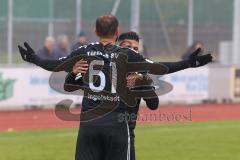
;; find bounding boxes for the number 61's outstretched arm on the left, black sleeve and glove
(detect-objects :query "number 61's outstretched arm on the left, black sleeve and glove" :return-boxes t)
[18,42,82,71]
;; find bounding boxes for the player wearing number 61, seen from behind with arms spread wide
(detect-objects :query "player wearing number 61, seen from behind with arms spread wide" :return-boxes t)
[18,15,212,160]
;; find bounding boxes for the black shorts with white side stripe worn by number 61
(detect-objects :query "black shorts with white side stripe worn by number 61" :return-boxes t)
[75,122,130,160]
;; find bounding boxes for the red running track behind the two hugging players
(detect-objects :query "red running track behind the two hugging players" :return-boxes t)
[0,104,240,131]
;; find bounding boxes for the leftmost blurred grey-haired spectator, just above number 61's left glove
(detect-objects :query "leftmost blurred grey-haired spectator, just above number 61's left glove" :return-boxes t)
[37,37,57,60]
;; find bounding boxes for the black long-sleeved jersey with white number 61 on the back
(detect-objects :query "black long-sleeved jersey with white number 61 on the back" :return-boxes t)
[34,42,188,124]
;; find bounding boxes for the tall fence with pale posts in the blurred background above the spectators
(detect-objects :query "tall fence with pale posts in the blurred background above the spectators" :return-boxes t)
[0,0,233,63]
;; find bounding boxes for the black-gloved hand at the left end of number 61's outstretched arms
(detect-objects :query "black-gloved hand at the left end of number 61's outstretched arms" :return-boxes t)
[18,42,36,63]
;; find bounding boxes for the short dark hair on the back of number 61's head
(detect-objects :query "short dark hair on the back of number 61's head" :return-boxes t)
[96,15,119,37]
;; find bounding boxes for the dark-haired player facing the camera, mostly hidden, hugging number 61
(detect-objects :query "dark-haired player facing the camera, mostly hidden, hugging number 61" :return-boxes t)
[66,32,159,160]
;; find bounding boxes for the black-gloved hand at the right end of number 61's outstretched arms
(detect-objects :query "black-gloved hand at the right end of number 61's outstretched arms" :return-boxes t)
[188,48,212,67]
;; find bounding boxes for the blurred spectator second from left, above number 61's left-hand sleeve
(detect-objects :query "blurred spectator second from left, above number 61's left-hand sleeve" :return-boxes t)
[53,35,69,58]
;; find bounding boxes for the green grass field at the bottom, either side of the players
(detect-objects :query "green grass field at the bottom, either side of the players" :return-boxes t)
[0,121,240,160]
